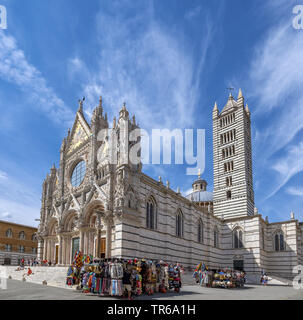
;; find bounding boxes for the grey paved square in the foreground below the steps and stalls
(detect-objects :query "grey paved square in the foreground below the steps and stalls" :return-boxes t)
[0,280,303,301]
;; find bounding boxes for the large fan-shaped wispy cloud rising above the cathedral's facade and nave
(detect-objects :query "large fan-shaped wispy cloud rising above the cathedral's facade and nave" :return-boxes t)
[69,2,213,129]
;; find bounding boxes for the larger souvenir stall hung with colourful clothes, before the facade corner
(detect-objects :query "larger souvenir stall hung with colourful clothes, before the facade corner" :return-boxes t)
[66,252,184,300]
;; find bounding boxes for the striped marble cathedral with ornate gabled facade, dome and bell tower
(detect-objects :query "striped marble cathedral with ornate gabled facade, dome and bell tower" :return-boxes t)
[38,90,303,278]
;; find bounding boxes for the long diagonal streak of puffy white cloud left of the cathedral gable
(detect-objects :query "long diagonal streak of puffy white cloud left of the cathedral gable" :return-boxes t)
[0,30,72,121]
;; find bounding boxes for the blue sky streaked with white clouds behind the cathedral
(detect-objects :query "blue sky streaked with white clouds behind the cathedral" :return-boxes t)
[0,0,303,225]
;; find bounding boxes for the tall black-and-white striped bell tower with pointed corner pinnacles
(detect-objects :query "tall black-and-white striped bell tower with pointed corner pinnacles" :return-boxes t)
[213,89,254,219]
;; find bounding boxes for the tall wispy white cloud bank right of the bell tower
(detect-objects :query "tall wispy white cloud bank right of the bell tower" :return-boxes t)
[246,5,303,199]
